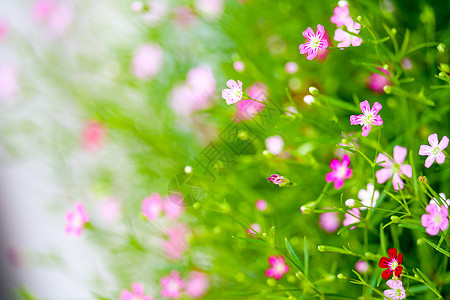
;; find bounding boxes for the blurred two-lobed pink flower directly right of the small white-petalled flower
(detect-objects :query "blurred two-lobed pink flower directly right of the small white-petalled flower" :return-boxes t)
[234,82,267,122]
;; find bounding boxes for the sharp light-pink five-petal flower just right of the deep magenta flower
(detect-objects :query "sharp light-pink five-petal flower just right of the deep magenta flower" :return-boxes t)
[375,146,412,191]
